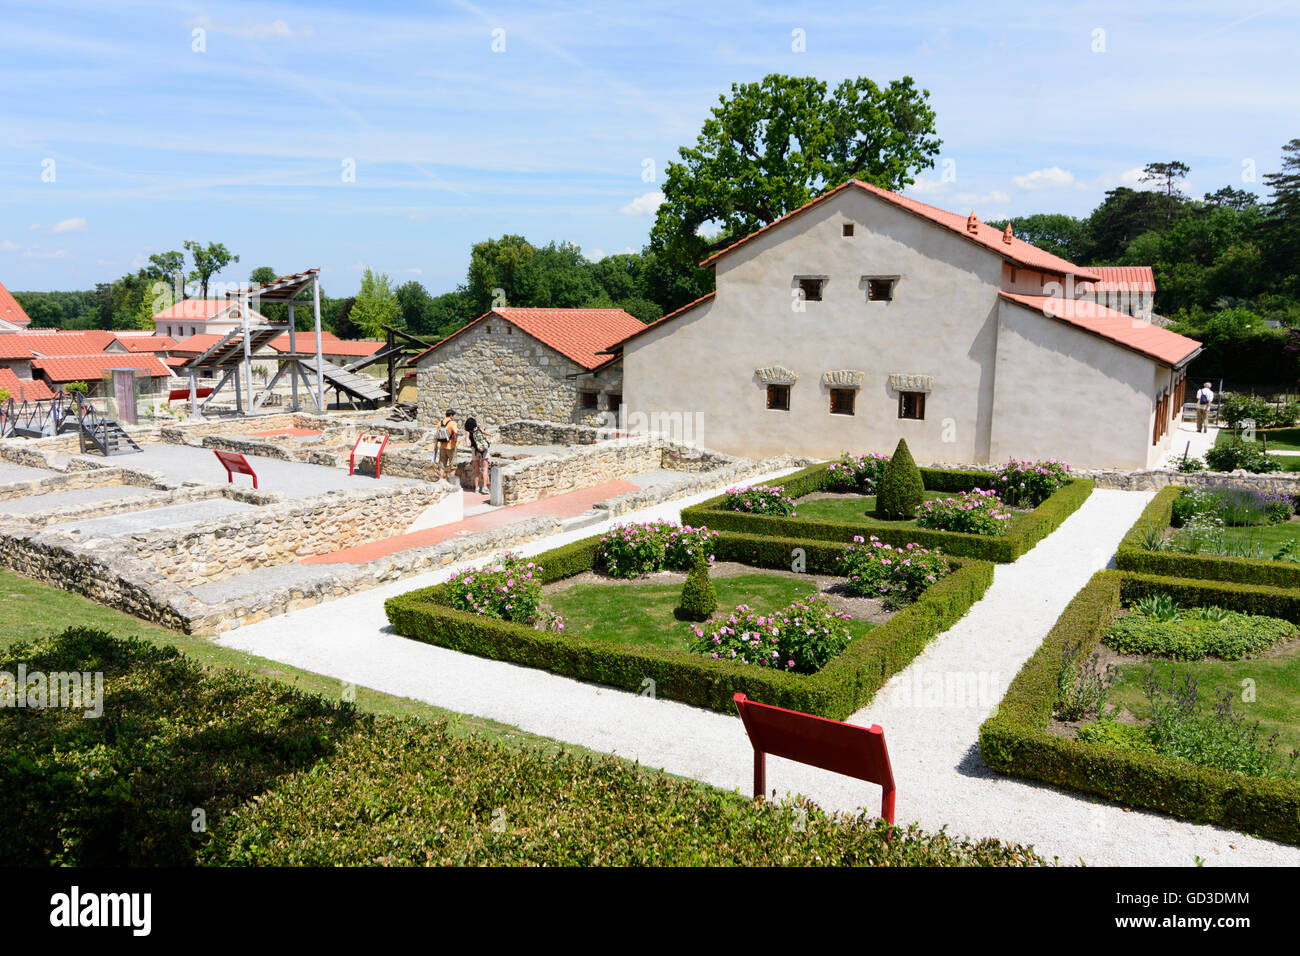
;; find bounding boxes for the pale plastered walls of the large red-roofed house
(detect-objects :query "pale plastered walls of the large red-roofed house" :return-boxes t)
[624,190,1170,467]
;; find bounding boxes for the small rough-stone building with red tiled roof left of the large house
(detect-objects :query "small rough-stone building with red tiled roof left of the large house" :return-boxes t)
[410,308,645,427]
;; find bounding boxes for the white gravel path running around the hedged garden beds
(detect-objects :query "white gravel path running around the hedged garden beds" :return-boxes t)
[220,481,1300,866]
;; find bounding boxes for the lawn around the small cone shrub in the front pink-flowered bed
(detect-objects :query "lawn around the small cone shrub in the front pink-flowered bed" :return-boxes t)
[545,571,874,650]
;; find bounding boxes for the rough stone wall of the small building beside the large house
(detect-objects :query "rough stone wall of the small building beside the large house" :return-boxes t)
[416,315,623,431]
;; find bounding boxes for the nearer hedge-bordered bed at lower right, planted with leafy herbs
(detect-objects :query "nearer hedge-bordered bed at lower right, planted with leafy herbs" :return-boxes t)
[980,571,1300,843]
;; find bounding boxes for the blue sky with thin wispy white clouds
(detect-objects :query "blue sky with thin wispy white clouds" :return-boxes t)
[0,0,1300,295]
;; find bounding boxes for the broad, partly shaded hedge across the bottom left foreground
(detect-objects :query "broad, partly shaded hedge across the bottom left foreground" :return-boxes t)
[0,630,1044,866]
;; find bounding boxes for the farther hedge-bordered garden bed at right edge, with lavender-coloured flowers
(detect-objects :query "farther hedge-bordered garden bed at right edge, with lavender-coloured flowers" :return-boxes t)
[1115,485,1300,589]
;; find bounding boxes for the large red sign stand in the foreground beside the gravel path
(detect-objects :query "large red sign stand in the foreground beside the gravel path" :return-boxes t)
[732,693,894,823]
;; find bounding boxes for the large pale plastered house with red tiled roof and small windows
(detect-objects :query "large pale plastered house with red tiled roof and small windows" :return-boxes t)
[613,181,1200,468]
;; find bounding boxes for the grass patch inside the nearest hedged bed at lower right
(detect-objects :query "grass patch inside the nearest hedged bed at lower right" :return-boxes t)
[1109,650,1300,753]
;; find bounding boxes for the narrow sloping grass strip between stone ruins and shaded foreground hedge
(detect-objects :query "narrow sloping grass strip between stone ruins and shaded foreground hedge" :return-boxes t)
[0,568,575,749]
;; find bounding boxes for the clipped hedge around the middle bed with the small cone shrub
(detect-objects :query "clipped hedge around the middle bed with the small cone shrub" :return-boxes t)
[385,532,993,719]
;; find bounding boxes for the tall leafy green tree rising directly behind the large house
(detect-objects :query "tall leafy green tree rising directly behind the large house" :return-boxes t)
[650,74,941,268]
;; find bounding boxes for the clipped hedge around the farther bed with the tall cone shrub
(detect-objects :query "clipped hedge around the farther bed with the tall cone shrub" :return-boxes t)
[681,464,1093,562]
